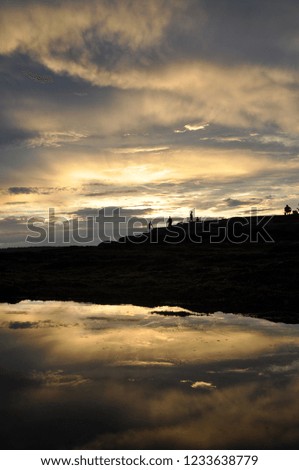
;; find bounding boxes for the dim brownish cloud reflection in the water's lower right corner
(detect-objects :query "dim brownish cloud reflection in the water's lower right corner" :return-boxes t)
[84,380,298,449]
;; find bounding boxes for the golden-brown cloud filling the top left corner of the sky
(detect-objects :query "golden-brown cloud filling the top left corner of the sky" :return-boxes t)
[1,0,179,56]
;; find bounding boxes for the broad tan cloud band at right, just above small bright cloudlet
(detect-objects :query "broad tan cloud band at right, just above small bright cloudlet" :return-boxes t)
[23,61,299,132]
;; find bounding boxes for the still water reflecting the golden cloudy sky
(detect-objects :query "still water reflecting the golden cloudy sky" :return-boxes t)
[0,301,299,449]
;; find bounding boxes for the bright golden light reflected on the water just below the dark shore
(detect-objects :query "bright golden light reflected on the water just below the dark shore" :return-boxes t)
[3,302,299,367]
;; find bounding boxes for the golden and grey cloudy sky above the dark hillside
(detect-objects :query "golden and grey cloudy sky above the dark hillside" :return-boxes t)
[0,0,299,247]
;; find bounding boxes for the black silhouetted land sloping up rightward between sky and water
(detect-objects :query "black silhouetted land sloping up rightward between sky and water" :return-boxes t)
[0,215,299,323]
